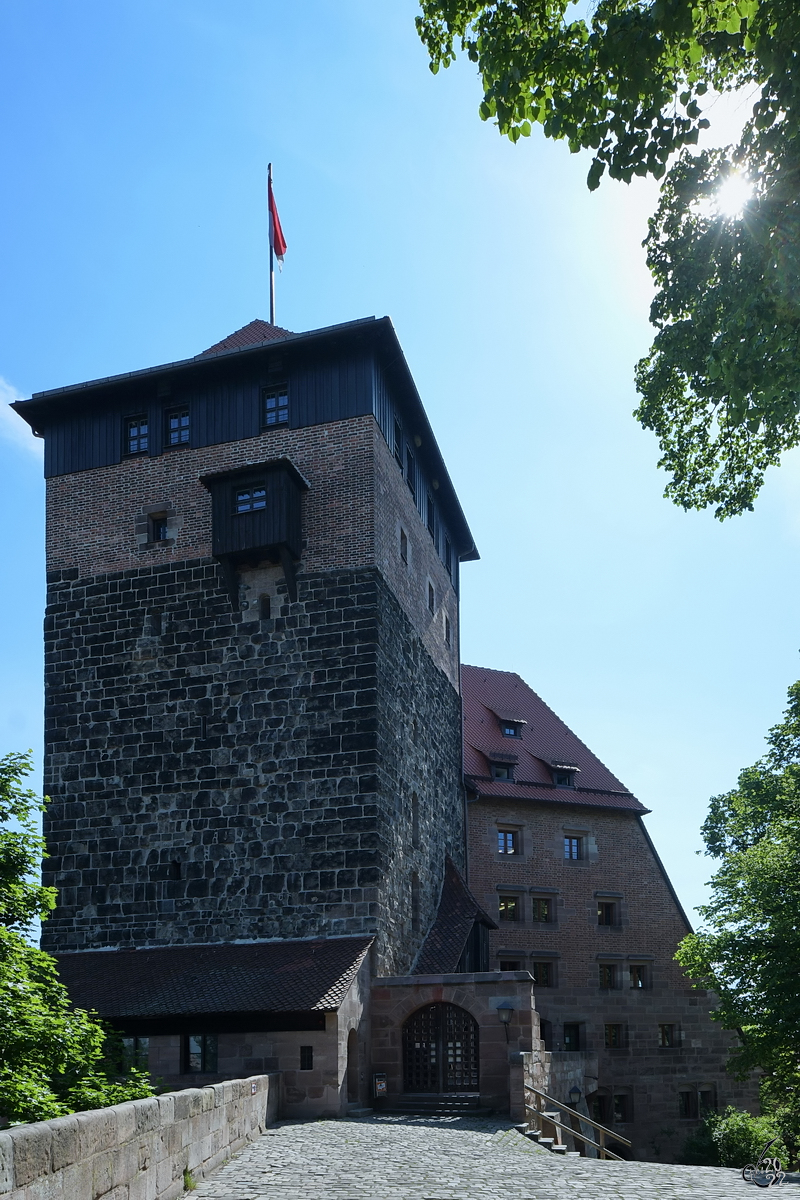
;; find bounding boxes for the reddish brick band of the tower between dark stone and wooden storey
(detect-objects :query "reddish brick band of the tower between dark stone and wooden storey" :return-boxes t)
[47,416,458,688]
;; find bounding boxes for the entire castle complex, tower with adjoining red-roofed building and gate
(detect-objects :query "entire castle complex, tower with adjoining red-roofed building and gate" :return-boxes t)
[13,318,746,1158]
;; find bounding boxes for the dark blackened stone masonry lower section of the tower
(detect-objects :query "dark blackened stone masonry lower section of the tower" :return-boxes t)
[42,558,463,973]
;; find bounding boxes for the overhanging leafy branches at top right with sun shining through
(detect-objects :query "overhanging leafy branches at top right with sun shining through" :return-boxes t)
[417,0,800,517]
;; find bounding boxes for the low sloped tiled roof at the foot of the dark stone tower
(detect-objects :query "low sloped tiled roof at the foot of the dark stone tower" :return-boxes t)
[56,937,372,1018]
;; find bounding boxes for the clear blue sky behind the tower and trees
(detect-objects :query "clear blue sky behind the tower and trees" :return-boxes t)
[0,0,800,908]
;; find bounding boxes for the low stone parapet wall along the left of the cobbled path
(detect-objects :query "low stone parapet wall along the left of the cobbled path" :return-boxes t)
[0,1074,281,1200]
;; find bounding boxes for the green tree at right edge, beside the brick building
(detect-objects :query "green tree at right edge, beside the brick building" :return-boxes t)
[678,683,800,1153]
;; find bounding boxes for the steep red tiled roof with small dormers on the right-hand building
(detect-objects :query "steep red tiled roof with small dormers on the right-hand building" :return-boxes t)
[462,666,649,812]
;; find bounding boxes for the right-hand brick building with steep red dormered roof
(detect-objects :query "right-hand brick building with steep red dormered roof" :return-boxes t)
[462,666,754,1158]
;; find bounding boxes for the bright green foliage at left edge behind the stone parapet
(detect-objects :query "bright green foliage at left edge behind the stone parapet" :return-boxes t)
[0,754,154,1123]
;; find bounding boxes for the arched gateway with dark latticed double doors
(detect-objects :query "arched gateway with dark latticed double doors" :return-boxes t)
[403,1004,479,1092]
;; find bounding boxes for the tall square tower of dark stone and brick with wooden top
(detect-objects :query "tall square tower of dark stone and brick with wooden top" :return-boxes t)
[14,318,477,974]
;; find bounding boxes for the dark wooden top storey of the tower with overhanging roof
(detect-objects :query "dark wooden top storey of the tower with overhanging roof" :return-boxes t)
[12,317,477,560]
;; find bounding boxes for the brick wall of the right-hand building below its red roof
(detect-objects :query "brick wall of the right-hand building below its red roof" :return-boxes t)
[468,800,757,1159]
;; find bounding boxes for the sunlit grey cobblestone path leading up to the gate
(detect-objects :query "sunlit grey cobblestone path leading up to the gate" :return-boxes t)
[193,1116,762,1200]
